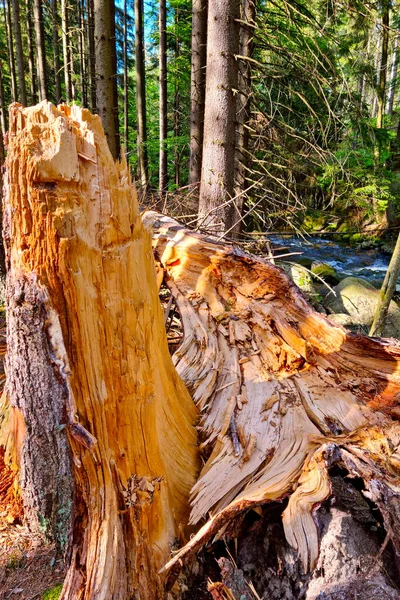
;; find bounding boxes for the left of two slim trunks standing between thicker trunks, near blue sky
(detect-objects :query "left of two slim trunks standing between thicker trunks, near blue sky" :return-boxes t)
[135,0,149,193]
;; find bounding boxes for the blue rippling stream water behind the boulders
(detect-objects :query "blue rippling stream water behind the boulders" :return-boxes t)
[268,235,390,287]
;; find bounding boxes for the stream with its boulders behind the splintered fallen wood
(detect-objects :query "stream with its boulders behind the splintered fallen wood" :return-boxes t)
[268,235,400,339]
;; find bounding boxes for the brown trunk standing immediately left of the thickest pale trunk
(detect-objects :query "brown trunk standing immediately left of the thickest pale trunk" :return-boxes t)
[189,0,208,184]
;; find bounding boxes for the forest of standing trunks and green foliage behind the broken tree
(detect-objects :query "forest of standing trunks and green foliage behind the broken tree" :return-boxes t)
[0,0,400,241]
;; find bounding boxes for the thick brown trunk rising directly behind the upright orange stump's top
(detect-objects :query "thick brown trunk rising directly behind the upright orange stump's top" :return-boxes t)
[94,0,120,158]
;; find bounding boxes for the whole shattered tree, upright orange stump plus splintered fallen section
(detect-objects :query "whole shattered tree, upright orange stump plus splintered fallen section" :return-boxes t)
[5,103,400,600]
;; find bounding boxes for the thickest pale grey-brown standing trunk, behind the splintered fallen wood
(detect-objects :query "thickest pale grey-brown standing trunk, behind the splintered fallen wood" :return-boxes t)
[198,0,240,234]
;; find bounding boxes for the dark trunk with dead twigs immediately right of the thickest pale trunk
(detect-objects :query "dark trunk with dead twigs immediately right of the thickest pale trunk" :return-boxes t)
[231,0,256,233]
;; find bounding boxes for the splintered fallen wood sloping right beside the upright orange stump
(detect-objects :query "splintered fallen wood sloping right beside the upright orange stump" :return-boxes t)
[143,212,400,578]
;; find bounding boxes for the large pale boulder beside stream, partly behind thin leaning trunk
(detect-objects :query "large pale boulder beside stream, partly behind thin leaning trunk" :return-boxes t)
[324,277,400,339]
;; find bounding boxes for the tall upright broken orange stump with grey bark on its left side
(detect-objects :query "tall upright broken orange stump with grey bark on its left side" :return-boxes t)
[5,102,197,600]
